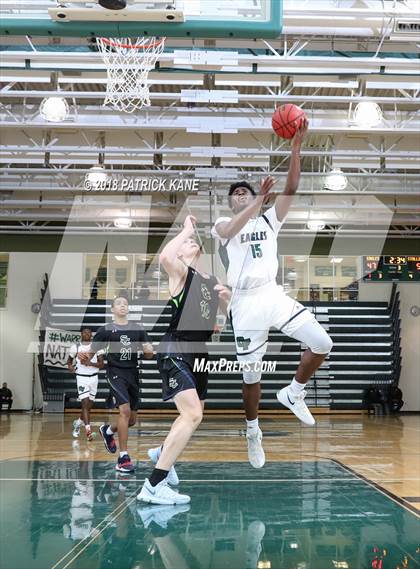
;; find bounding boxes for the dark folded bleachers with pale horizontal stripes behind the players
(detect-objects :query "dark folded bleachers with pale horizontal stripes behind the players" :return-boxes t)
[39,272,401,410]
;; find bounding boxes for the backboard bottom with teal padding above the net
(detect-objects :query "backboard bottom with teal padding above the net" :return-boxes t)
[0,0,282,38]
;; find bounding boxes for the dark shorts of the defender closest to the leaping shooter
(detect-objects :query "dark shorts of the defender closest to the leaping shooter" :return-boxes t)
[158,354,208,401]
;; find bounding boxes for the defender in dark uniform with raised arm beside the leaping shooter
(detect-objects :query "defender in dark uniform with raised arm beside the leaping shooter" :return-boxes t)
[137,215,230,504]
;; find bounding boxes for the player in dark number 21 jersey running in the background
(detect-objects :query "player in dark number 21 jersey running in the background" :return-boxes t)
[82,296,153,472]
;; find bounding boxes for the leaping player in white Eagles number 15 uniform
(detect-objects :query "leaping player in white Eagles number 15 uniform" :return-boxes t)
[212,119,332,468]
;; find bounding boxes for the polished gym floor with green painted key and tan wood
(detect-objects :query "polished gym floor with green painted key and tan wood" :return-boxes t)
[0,413,420,569]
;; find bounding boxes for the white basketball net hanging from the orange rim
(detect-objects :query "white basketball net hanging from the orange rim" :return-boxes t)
[97,37,166,113]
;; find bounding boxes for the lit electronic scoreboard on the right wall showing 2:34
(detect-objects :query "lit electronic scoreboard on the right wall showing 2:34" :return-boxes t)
[363,255,420,282]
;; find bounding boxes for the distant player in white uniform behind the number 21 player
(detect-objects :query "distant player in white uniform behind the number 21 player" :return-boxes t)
[67,327,104,441]
